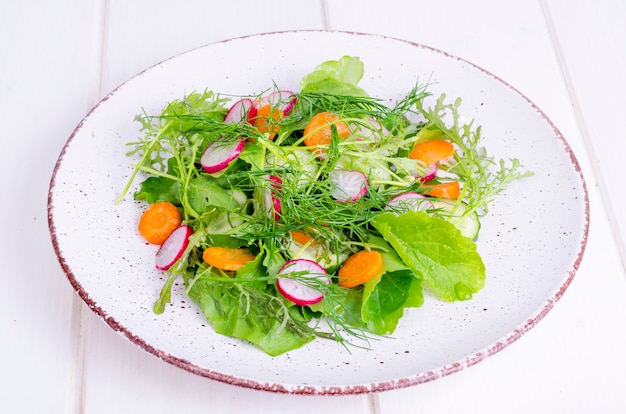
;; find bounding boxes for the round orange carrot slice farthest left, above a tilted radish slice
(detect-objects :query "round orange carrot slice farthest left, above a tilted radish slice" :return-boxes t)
[137,201,182,245]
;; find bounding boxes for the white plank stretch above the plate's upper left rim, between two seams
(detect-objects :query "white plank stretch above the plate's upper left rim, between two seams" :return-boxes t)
[99,0,324,94]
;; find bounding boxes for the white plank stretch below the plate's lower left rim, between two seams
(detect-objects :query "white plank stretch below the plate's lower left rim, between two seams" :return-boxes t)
[85,310,371,414]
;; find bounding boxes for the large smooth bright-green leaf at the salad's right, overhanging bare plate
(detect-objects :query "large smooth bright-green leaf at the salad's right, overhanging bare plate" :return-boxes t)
[371,211,486,302]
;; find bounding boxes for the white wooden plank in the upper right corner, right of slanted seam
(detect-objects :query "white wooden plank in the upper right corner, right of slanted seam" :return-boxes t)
[545,0,626,261]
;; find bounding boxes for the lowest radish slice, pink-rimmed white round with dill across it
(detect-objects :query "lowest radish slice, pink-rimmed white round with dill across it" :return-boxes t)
[276,259,330,306]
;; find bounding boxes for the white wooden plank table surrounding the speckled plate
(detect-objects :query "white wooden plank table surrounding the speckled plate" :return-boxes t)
[0,0,626,414]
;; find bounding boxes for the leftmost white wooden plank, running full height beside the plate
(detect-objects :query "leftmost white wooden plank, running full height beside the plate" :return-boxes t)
[0,0,97,413]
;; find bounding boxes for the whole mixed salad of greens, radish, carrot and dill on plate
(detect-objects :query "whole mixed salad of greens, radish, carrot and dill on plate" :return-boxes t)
[118,56,530,356]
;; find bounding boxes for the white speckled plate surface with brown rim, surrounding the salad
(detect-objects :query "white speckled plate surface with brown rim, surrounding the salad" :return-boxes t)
[49,31,589,394]
